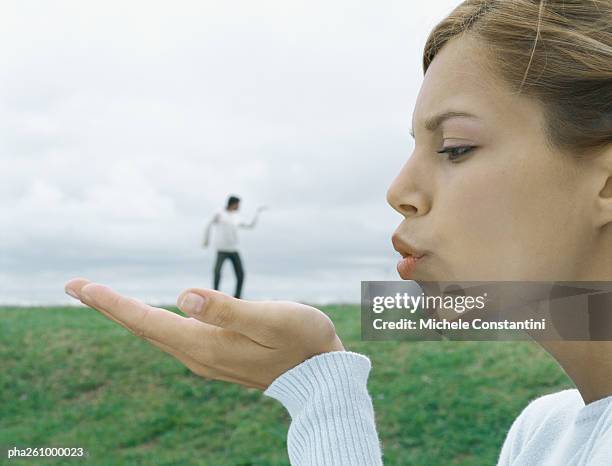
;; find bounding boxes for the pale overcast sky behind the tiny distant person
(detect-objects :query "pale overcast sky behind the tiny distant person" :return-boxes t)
[0,0,459,304]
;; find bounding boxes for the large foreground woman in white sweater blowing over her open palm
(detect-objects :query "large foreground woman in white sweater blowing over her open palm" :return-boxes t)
[66,0,612,465]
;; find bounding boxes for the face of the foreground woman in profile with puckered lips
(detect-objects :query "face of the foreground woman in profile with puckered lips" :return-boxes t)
[388,36,593,281]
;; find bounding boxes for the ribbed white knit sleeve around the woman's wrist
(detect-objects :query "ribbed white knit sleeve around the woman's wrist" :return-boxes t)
[264,351,382,466]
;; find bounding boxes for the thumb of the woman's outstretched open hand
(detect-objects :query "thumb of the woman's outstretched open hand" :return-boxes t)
[177,288,291,344]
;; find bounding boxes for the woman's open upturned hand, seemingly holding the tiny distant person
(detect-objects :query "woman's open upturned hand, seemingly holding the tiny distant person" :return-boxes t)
[65,278,344,390]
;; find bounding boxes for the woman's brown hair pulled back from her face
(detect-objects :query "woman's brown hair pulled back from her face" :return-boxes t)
[423,0,612,156]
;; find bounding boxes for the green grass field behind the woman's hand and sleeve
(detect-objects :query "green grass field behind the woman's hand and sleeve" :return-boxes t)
[0,306,572,466]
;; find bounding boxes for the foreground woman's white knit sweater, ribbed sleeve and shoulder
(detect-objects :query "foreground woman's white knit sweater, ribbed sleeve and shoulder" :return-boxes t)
[264,351,612,466]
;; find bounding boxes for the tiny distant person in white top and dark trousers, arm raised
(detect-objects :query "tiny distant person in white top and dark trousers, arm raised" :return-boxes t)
[202,196,266,298]
